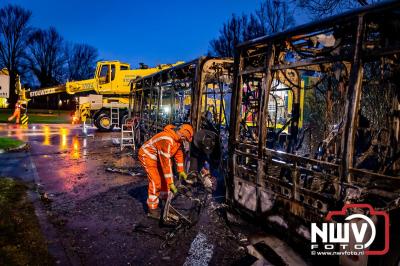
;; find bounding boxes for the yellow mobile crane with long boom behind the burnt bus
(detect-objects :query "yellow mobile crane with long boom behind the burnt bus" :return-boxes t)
[30,61,183,131]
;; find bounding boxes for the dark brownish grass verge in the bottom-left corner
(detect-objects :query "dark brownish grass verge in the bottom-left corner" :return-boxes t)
[0,177,54,265]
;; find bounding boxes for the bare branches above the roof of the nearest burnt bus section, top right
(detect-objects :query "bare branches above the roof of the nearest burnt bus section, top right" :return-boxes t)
[296,0,381,16]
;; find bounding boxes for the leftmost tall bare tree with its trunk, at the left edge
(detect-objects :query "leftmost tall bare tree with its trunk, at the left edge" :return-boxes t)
[0,5,31,105]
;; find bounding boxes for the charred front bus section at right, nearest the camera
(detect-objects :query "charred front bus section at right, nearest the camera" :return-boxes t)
[226,1,400,265]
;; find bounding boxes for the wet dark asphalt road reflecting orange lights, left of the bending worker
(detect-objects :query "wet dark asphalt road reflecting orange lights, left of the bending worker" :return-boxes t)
[0,124,253,265]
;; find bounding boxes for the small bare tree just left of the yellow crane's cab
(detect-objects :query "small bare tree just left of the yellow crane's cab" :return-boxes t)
[65,44,99,80]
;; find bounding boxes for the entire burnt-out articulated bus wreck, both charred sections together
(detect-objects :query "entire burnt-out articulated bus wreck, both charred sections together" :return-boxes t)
[130,2,400,265]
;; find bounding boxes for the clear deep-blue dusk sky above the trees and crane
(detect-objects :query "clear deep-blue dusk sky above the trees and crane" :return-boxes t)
[0,0,310,67]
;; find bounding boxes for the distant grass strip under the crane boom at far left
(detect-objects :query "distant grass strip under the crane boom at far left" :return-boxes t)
[0,109,71,124]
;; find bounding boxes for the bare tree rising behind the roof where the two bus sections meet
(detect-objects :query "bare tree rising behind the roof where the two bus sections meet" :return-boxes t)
[209,0,294,57]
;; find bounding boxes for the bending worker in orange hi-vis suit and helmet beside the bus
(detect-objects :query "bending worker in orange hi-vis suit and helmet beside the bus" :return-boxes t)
[139,124,193,219]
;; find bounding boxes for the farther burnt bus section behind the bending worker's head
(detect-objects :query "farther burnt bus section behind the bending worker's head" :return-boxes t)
[130,57,233,168]
